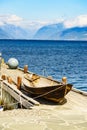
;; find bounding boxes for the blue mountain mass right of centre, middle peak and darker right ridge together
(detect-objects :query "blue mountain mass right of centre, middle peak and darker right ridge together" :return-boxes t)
[34,23,87,40]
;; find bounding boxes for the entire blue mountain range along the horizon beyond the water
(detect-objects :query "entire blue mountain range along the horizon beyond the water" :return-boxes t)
[0,23,87,40]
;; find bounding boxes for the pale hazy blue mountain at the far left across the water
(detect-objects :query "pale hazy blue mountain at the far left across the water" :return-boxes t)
[0,24,31,39]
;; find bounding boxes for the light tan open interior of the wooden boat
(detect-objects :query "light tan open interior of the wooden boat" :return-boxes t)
[24,74,62,87]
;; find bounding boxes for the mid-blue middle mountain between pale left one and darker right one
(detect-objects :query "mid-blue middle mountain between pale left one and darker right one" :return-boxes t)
[33,23,65,40]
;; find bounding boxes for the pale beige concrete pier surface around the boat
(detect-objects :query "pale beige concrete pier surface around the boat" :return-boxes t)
[0,64,87,130]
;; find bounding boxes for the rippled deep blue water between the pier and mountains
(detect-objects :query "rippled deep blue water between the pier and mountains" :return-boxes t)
[0,40,87,91]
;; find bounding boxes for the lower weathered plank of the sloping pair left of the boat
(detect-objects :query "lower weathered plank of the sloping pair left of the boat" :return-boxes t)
[3,84,33,108]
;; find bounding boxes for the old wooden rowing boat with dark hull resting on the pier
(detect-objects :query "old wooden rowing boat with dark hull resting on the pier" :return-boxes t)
[23,73,72,103]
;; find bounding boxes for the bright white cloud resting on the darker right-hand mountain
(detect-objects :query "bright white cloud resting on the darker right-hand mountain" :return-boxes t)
[64,15,87,28]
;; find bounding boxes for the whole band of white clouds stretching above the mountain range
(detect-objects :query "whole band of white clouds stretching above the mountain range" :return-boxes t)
[0,14,87,31]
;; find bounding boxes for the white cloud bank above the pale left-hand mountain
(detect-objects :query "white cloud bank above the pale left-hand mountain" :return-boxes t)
[0,14,48,30]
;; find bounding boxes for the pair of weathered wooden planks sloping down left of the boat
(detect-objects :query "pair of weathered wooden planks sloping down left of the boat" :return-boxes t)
[3,81,39,108]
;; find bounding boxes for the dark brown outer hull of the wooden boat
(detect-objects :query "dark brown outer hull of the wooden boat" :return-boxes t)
[24,84,72,102]
